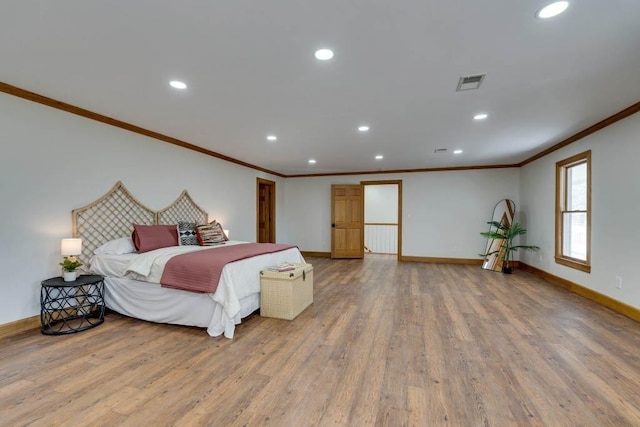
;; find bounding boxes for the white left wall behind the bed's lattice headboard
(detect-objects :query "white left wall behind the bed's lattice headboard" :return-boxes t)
[0,94,283,324]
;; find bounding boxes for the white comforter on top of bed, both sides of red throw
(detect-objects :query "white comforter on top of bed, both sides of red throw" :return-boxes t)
[92,241,304,319]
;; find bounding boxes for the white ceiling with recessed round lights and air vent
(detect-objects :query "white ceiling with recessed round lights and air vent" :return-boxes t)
[0,0,640,175]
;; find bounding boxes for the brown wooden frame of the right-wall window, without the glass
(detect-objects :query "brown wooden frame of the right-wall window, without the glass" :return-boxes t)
[555,150,591,273]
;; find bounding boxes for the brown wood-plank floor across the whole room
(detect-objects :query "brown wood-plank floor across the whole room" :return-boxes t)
[0,256,640,426]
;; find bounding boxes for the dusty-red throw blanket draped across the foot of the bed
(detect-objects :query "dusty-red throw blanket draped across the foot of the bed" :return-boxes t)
[160,243,295,293]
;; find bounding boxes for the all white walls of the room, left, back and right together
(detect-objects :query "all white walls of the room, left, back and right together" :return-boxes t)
[5,87,640,324]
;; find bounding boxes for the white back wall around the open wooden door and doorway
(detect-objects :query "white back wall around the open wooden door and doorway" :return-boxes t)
[283,168,519,258]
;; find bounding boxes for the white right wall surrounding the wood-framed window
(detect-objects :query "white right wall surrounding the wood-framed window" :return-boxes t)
[520,110,640,307]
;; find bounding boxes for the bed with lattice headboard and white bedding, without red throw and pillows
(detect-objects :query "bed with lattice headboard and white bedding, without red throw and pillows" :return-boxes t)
[72,182,304,338]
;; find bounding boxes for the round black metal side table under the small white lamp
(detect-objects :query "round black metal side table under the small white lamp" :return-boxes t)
[40,275,104,335]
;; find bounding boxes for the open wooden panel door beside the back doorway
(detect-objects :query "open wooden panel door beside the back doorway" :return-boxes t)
[331,185,364,258]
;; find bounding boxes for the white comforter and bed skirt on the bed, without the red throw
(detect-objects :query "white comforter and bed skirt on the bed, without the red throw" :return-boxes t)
[90,241,304,338]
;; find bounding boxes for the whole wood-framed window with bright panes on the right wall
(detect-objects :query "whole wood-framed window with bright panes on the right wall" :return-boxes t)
[556,151,591,273]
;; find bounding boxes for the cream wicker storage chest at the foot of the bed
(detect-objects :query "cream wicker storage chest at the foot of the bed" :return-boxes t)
[260,264,313,320]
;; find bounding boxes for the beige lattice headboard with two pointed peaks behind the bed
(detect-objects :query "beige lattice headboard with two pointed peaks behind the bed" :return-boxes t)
[71,181,209,263]
